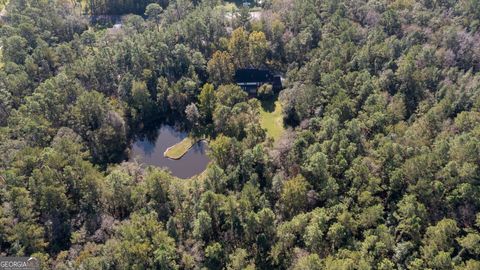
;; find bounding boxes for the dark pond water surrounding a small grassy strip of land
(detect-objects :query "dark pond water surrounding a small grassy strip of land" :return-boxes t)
[131,125,210,178]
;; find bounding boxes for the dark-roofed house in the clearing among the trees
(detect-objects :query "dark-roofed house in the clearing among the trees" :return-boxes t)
[235,68,282,95]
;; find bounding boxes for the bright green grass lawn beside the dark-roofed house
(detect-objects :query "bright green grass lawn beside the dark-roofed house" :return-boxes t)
[260,100,285,141]
